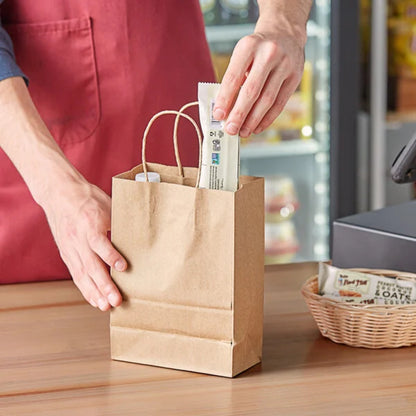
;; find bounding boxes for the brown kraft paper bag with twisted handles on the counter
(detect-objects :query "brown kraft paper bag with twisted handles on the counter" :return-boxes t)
[110,107,264,377]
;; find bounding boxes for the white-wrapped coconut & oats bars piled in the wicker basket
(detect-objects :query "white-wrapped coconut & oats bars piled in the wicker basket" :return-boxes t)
[318,263,416,305]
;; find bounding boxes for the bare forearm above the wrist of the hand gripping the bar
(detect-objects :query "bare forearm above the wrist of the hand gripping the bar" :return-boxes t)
[256,0,313,45]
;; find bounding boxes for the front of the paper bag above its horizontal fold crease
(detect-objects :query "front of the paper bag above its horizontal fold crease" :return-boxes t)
[112,179,234,310]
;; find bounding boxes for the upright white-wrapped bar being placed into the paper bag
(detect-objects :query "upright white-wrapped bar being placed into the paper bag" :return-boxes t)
[198,82,240,192]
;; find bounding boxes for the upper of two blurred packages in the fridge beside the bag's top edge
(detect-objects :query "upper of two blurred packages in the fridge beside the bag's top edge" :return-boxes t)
[264,176,299,222]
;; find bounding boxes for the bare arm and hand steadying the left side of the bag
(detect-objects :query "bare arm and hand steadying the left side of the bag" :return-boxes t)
[0,77,127,310]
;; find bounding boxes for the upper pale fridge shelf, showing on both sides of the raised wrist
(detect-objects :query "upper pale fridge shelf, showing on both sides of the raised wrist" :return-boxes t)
[205,20,323,43]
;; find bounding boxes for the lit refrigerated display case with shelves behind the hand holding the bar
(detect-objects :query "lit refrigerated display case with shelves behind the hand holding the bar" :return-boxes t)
[201,0,331,263]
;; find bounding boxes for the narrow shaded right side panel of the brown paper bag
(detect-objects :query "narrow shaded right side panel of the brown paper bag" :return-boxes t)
[233,178,264,376]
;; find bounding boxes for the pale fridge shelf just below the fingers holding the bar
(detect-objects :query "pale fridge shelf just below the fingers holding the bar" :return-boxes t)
[240,139,320,159]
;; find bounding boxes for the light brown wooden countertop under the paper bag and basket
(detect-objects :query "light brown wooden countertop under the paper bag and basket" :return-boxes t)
[0,263,416,416]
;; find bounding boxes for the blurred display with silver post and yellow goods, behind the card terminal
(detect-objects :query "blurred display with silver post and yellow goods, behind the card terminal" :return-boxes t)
[358,0,416,211]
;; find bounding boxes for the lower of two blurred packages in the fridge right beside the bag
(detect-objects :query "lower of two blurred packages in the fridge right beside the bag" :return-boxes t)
[264,220,299,264]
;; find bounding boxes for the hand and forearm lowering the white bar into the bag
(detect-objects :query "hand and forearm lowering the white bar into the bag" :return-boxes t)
[214,0,312,137]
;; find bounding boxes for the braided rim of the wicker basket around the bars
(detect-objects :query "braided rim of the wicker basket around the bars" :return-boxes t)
[301,268,416,312]
